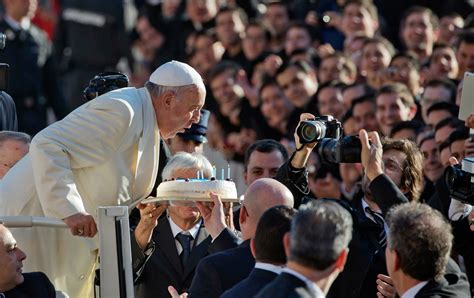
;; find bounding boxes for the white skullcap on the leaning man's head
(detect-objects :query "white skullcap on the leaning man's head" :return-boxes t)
[150,60,204,87]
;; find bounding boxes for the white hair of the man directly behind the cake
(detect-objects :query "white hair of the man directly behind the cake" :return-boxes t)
[161,152,212,180]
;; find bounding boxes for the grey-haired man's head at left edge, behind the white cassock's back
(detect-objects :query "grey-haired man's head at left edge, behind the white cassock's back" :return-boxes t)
[0,130,31,179]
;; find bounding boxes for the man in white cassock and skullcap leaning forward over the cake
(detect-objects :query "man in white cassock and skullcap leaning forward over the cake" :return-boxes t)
[0,61,206,297]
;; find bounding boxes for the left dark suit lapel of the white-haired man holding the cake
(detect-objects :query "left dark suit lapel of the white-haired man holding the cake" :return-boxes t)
[153,216,183,275]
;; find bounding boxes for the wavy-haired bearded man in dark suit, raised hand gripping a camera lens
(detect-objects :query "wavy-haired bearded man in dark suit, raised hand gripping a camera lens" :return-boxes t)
[327,130,423,297]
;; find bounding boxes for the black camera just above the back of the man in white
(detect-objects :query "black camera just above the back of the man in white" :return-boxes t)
[83,71,128,101]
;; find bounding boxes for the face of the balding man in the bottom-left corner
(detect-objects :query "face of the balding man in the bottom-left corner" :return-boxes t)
[0,226,26,292]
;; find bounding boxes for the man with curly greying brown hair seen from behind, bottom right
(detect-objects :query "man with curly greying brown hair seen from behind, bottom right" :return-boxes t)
[385,202,470,297]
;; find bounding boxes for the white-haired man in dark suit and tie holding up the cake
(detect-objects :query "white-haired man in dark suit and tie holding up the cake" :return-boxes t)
[131,152,234,297]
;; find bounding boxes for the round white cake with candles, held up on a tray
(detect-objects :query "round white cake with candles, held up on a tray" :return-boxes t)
[140,178,238,203]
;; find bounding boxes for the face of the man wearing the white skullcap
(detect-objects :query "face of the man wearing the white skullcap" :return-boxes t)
[159,85,206,139]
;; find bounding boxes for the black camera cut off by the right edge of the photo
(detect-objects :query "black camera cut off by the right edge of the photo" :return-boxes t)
[444,157,474,205]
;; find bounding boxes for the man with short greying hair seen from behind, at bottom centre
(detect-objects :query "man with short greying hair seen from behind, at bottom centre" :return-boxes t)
[256,199,352,298]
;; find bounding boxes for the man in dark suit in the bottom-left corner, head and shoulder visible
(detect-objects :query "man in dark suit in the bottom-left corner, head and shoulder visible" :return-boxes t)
[0,224,56,298]
